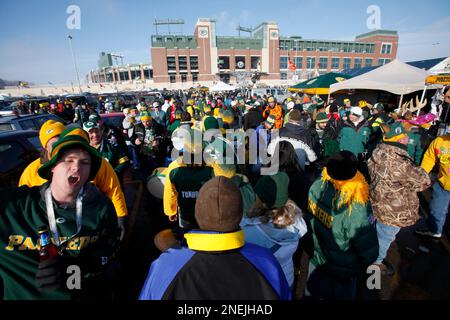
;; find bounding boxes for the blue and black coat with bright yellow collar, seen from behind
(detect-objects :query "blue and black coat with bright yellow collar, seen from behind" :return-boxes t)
[139,230,291,300]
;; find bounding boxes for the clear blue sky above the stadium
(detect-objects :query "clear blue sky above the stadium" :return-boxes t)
[0,0,450,84]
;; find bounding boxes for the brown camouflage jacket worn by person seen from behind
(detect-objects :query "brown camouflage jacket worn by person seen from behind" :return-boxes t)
[368,143,431,227]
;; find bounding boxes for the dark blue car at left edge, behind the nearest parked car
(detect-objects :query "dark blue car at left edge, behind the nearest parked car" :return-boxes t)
[0,113,66,131]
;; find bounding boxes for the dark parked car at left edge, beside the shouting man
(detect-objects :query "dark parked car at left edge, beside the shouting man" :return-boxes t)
[0,130,42,187]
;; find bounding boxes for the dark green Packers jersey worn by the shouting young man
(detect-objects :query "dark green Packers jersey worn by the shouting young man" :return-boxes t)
[0,183,120,300]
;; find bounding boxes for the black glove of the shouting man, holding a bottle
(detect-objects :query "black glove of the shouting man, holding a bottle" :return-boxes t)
[36,256,63,291]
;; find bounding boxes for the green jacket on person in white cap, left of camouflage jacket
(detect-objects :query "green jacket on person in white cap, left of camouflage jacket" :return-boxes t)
[338,121,370,157]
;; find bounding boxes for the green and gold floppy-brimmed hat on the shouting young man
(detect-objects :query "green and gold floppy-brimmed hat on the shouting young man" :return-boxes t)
[38,127,102,181]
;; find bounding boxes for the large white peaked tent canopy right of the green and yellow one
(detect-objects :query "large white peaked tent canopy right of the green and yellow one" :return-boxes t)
[330,60,429,95]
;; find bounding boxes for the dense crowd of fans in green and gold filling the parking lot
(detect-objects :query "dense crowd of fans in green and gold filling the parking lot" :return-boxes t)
[0,88,450,299]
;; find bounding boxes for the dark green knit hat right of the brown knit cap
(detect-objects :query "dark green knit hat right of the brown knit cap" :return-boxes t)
[255,172,289,209]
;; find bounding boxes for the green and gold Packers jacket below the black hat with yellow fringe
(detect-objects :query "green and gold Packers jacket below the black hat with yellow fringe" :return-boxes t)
[306,169,378,279]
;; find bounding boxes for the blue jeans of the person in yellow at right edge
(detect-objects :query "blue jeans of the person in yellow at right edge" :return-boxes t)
[427,182,450,234]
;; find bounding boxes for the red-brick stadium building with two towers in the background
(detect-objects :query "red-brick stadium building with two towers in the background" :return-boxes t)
[151,18,398,84]
